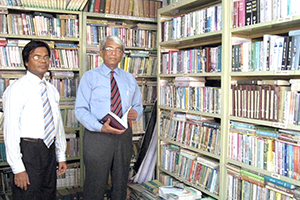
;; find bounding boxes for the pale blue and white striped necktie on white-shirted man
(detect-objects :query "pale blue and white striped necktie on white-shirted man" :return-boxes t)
[41,81,55,148]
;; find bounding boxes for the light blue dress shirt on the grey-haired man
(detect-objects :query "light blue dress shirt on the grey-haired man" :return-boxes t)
[75,64,143,132]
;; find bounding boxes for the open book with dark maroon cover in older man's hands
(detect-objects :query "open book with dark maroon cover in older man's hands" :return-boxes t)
[99,106,131,130]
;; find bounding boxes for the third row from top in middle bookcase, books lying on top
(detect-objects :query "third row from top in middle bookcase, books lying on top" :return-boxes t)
[160,77,221,114]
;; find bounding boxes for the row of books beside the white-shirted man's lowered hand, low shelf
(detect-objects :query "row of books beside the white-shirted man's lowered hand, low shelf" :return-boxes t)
[57,163,80,187]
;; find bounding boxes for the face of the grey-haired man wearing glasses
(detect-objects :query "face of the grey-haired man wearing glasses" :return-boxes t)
[100,40,124,70]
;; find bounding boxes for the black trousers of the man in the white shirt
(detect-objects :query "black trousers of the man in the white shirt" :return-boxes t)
[12,139,56,200]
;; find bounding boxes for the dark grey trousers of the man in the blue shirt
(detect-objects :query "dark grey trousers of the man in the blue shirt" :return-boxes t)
[83,128,132,200]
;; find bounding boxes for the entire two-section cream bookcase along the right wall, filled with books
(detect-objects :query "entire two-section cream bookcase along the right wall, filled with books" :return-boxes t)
[157,0,300,200]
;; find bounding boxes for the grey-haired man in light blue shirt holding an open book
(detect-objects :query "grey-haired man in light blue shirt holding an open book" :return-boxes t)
[75,36,143,200]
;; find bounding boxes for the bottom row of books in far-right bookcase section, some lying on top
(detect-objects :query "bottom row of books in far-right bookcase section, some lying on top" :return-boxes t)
[227,164,300,200]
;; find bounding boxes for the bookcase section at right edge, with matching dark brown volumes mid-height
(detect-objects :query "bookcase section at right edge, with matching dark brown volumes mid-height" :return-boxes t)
[226,1,300,199]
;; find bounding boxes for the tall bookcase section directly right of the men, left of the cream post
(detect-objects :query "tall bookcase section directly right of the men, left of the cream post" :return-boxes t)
[157,0,228,199]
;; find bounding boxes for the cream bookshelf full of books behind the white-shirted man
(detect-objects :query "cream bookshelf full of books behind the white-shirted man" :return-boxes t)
[0,5,83,192]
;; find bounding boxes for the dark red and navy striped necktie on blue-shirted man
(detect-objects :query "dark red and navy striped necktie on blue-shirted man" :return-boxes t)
[110,71,123,117]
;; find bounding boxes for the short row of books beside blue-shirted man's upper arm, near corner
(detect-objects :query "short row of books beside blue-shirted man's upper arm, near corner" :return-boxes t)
[137,80,157,104]
